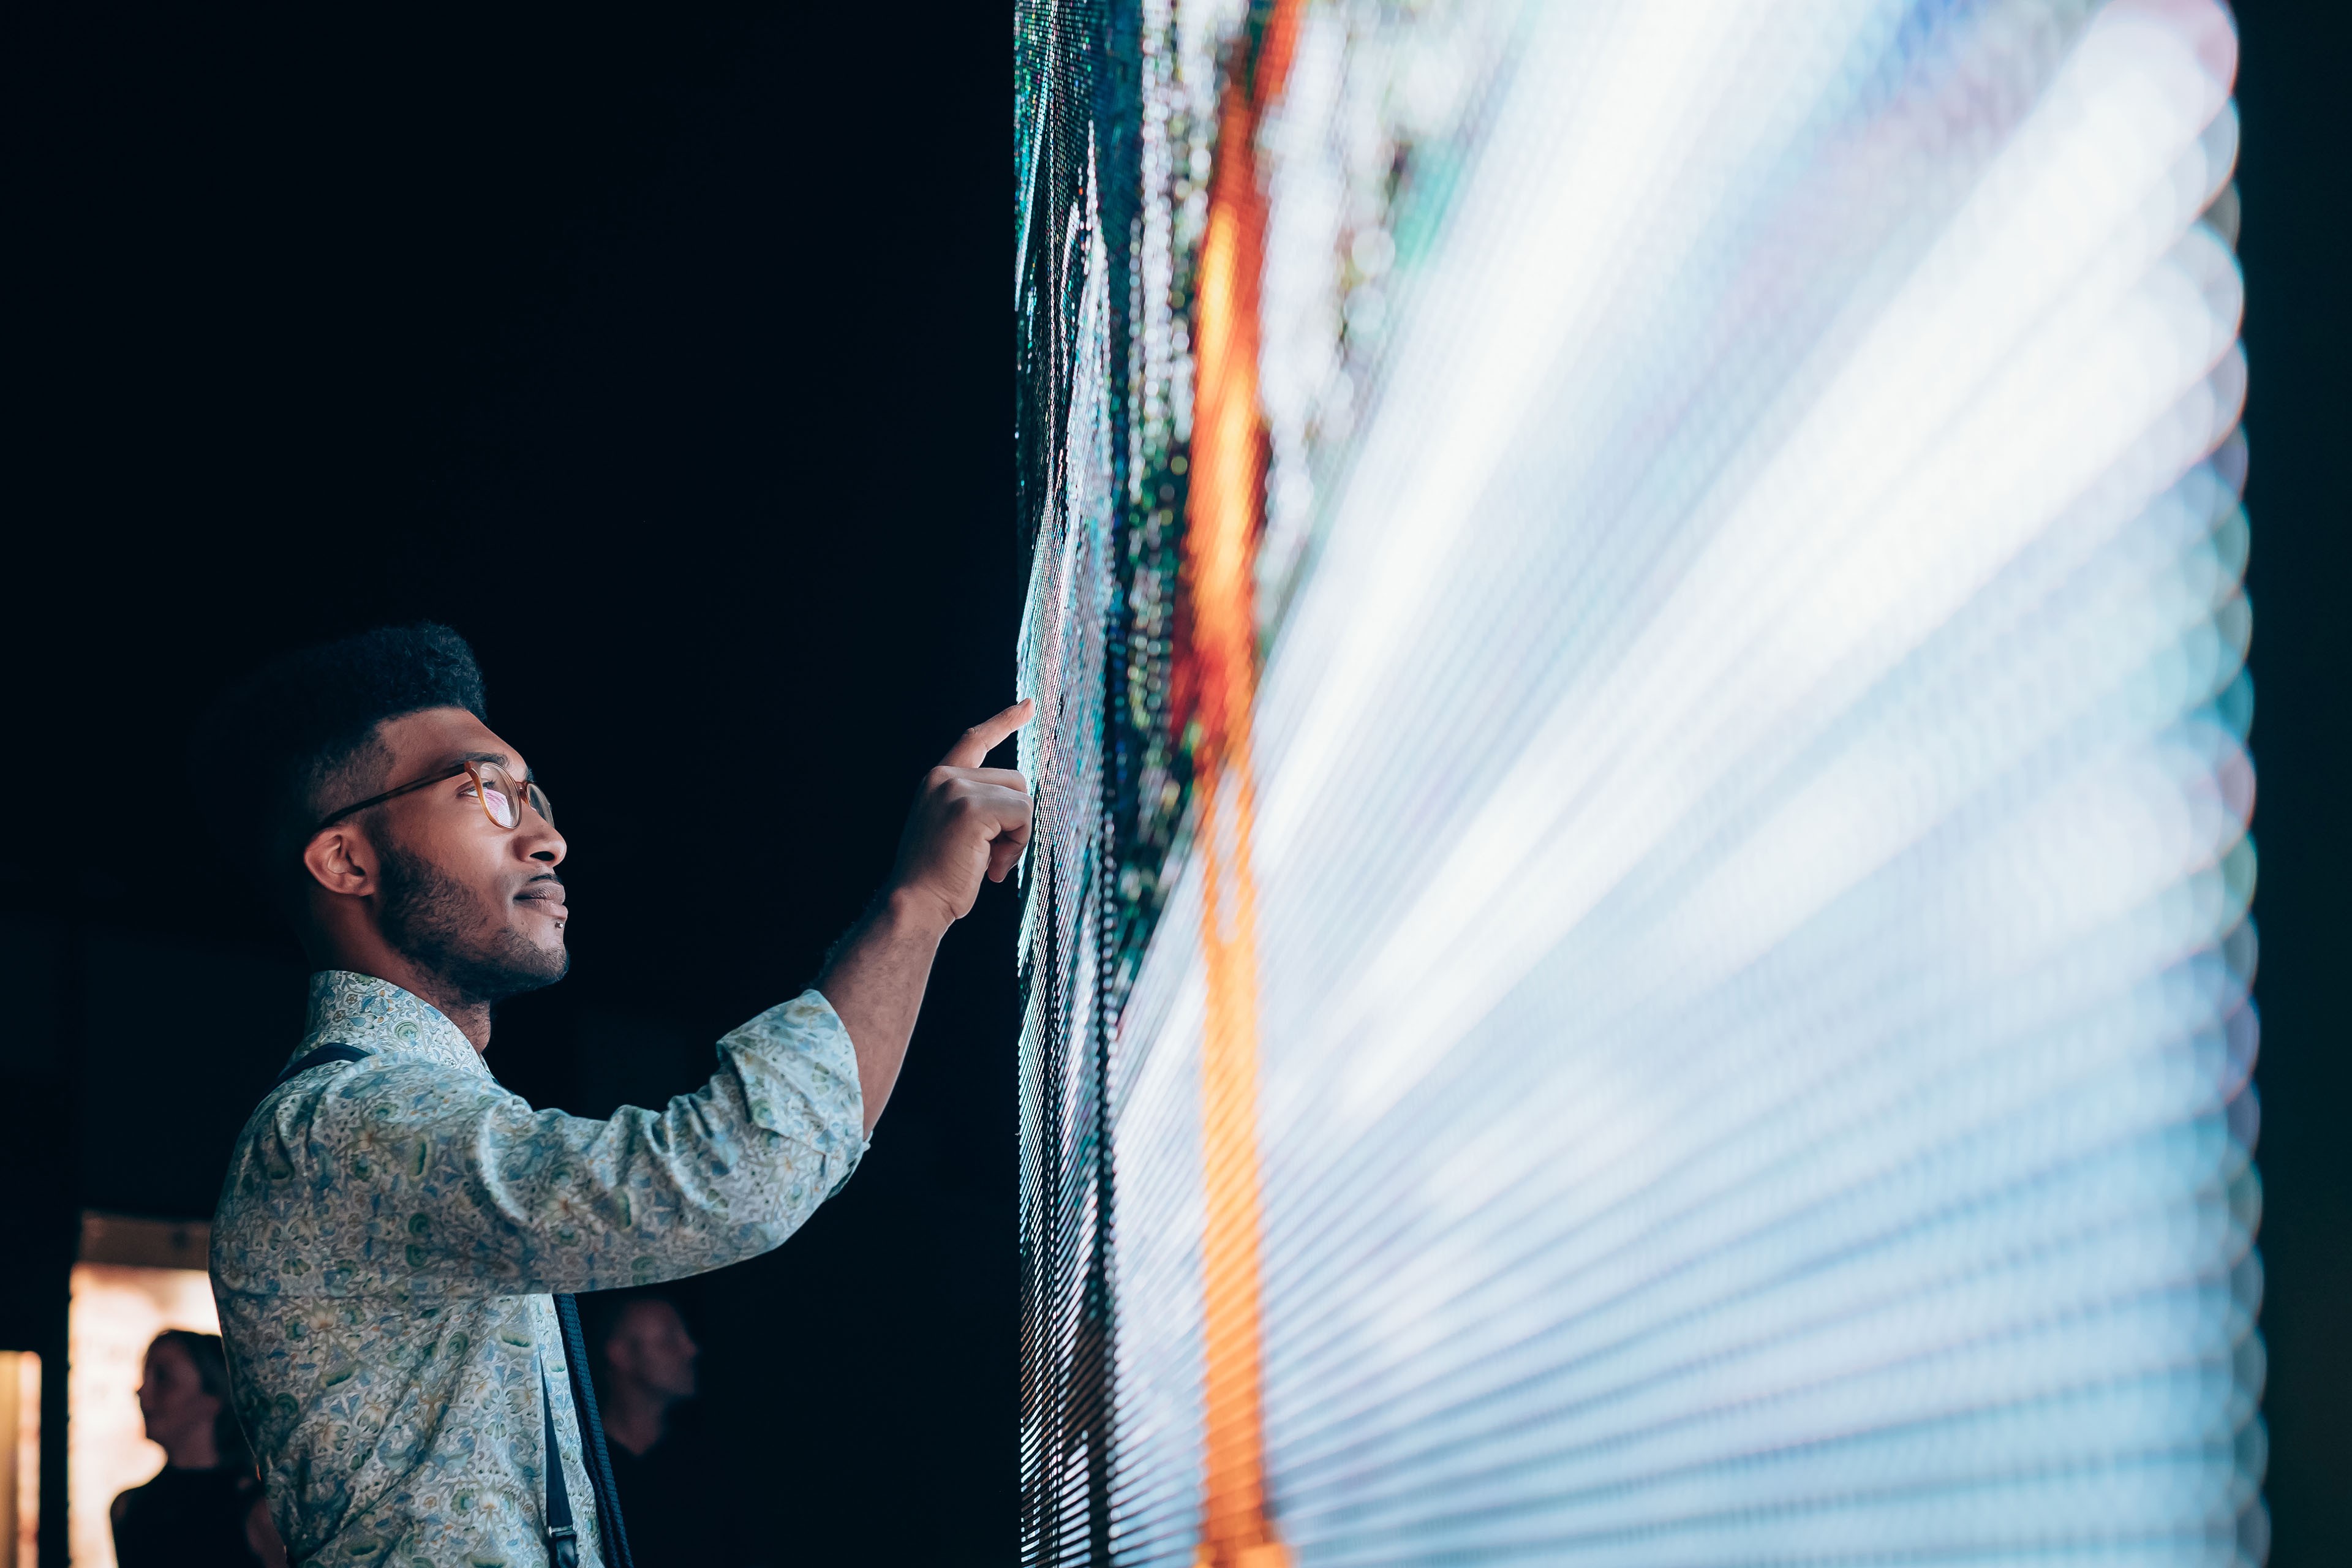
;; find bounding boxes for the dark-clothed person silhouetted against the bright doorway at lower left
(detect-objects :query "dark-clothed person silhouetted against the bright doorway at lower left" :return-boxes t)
[113,1329,287,1568]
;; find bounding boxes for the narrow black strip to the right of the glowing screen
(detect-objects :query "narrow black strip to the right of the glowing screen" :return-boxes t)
[2239,0,2352,1568]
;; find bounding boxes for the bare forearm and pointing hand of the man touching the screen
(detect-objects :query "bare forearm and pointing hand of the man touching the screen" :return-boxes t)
[816,698,1035,1133]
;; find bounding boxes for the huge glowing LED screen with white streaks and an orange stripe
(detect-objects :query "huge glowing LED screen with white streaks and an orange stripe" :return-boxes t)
[1014,0,2267,1568]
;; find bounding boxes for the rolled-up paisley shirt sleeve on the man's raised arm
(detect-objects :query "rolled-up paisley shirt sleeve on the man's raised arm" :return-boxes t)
[233,990,865,1295]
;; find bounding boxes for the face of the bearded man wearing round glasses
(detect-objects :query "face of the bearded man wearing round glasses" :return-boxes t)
[341,707,571,1001]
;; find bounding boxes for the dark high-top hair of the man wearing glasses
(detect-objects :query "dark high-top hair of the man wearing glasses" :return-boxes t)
[190,620,489,905]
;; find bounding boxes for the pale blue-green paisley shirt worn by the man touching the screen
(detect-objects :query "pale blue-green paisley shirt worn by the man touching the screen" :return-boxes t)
[212,971,865,1568]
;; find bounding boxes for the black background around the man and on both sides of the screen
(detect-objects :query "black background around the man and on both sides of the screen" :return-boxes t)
[0,5,2352,1566]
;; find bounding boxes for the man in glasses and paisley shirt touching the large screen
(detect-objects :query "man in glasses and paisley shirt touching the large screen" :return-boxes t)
[198,625,1030,1568]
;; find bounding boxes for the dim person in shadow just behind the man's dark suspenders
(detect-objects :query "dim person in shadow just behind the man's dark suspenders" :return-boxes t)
[590,1295,776,1568]
